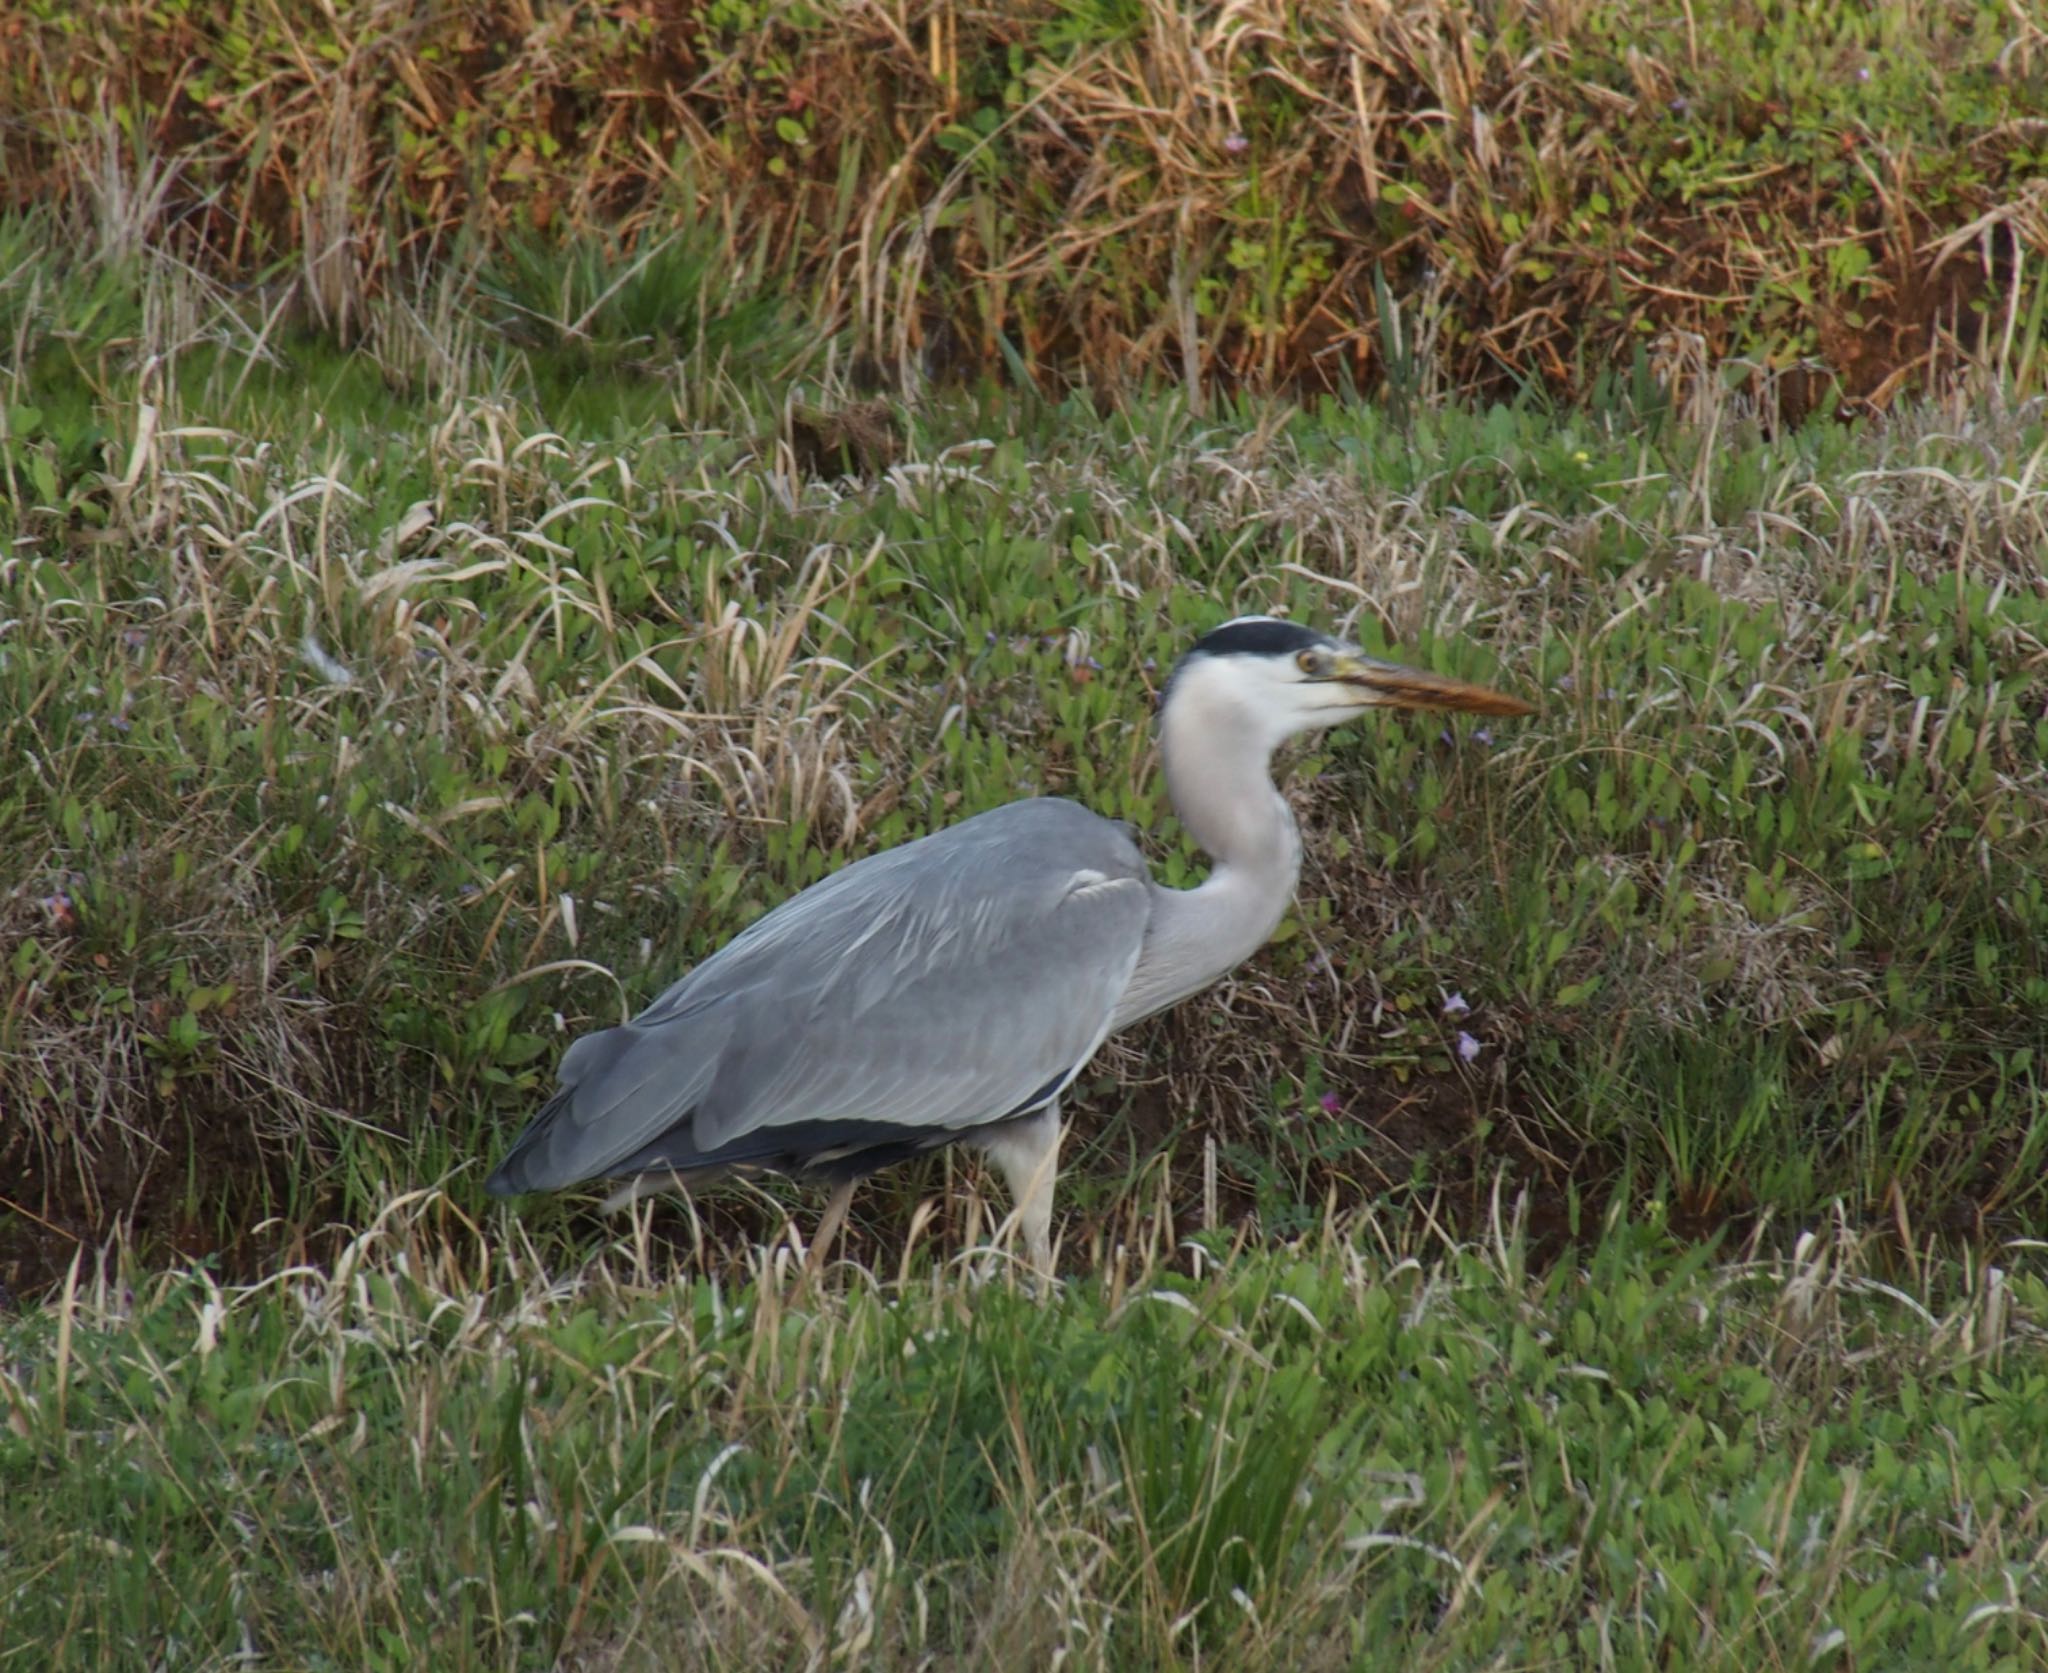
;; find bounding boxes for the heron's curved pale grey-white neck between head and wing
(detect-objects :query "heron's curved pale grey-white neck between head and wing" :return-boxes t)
[1114,683,1300,1028]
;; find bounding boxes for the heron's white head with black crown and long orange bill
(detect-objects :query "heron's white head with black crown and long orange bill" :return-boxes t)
[1159,616,1534,743]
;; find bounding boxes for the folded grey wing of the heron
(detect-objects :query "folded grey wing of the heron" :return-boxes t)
[489,801,1151,1194]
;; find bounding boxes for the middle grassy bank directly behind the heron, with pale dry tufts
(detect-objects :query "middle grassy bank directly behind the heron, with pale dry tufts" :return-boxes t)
[0,205,2048,1288]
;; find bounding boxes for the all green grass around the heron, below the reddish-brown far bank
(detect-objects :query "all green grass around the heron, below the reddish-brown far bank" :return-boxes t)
[0,88,2048,1669]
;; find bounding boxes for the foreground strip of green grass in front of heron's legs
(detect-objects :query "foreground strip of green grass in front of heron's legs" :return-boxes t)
[0,1194,2048,1669]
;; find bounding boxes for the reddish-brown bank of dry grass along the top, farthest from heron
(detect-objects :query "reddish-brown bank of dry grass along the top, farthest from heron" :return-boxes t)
[0,0,2048,401]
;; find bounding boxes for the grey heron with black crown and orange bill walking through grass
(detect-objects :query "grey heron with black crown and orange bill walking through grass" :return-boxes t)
[487,616,1532,1276]
